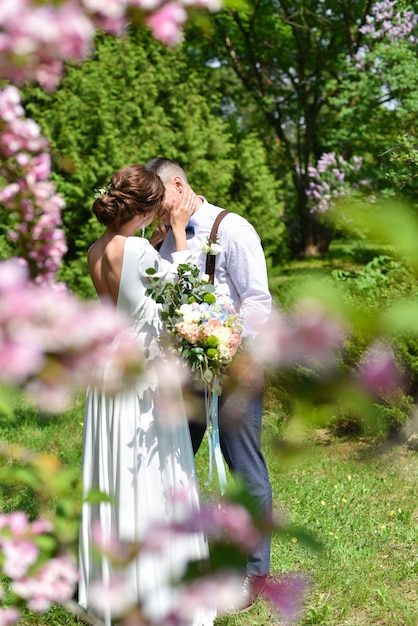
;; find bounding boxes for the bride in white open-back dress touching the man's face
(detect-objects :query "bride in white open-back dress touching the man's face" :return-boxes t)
[79,165,214,626]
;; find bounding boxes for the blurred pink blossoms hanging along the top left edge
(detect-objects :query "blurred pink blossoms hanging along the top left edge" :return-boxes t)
[0,0,220,90]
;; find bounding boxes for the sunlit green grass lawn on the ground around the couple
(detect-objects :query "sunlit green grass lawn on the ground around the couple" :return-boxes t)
[0,396,418,626]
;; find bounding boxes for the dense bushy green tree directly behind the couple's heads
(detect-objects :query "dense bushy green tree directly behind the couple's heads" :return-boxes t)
[25,27,286,295]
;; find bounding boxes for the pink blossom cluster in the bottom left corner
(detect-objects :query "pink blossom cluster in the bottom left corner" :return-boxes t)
[0,511,78,624]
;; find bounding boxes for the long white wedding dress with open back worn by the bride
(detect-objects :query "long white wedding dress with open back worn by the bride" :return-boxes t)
[79,237,215,626]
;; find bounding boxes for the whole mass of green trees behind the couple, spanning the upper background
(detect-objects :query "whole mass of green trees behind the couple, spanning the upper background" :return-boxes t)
[13,0,418,276]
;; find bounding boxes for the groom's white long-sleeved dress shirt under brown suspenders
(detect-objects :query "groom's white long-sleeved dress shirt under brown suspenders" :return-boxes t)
[160,198,271,337]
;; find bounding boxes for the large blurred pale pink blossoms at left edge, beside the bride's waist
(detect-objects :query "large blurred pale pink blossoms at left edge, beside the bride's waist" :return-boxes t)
[0,259,142,410]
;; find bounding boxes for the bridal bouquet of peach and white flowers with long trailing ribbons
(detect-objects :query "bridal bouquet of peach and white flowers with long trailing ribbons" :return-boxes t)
[147,263,242,492]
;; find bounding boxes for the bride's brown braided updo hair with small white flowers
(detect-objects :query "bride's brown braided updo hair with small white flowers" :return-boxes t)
[92,164,165,228]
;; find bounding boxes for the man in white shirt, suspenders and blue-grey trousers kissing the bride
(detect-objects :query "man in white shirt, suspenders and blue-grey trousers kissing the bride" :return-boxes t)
[146,157,272,609]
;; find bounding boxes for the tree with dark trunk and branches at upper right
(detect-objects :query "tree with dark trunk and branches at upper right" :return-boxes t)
[188,0,418,252]
